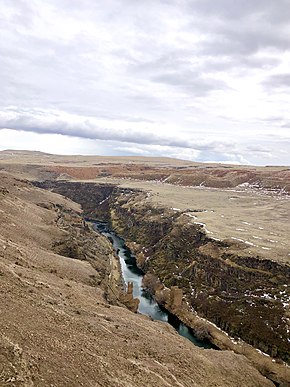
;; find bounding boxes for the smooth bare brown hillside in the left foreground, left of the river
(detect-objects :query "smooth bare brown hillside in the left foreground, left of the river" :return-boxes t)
[0,172,273,387]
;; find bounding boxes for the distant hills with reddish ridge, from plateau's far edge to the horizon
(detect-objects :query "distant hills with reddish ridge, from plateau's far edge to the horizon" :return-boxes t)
[0,150,290,194]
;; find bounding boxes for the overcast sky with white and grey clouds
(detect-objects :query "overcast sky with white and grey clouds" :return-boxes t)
[0,0,290,165]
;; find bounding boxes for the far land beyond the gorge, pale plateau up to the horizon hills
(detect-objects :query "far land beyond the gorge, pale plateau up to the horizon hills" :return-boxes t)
[0,151,290,264]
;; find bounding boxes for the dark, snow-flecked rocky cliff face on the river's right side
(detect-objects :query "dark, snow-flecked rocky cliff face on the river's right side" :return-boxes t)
[111,193,290,362]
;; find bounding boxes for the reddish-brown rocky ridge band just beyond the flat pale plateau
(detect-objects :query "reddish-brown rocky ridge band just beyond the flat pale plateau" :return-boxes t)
[46,164,290,193]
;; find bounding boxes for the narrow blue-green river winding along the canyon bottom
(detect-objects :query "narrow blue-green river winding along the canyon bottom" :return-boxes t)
[93,221,214,348]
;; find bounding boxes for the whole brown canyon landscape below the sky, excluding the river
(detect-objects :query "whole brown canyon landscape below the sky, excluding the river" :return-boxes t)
[0,151,290,386]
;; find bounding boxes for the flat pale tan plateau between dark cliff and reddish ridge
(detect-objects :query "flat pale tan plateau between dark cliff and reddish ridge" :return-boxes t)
[98,178,290,264]
